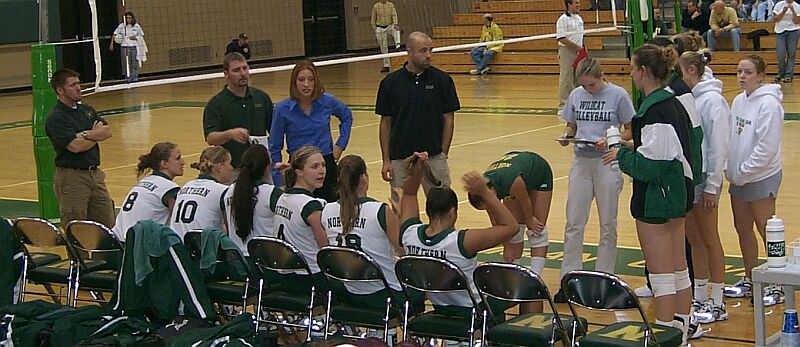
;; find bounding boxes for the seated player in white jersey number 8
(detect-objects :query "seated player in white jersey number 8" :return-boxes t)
[113,142,184,241]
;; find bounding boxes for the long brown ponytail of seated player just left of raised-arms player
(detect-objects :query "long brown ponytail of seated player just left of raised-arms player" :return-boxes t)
[338,155,367,236]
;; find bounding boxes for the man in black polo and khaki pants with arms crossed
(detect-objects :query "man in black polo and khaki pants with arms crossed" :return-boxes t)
[45,69,114,228]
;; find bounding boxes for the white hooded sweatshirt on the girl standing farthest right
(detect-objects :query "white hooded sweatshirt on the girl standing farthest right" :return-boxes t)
[725,84,783,186]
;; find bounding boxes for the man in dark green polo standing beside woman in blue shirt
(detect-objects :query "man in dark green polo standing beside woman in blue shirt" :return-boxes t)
[203,52,272,179]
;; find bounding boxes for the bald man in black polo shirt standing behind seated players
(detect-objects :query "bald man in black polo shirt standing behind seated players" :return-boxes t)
[375,32,461,201]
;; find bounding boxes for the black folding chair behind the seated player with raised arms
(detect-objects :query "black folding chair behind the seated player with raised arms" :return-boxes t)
[395,255,482,346]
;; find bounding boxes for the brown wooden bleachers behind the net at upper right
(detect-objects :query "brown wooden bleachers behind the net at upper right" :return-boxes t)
[392,0,777,74]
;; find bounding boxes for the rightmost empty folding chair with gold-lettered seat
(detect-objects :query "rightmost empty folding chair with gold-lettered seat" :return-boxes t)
[561,270,683,347]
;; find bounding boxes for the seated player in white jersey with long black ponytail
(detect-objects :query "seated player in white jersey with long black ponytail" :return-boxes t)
[223,145,281,256]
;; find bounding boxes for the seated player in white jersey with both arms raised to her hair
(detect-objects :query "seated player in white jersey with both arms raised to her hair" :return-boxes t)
[400,152,517,317]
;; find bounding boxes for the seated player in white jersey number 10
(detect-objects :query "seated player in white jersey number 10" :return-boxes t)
[170,146,233,238]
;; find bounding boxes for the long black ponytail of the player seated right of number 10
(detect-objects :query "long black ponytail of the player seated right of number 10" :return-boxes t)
[231,145,270,240]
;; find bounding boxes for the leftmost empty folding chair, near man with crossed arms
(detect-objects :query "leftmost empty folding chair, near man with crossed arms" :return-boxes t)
[14,217,75,305]
